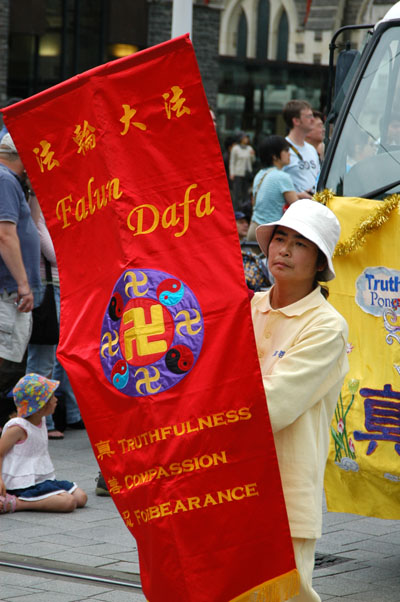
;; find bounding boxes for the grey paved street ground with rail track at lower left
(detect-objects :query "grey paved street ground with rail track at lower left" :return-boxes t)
[0,431,400,602]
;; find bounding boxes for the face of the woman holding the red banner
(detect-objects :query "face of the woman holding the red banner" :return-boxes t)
[268,226,323,285]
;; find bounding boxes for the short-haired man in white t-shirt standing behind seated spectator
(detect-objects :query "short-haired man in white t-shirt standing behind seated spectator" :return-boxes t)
[283,100,320,198]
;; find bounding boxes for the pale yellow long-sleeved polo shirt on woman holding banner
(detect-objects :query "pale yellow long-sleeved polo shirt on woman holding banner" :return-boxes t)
[251,286,348,539]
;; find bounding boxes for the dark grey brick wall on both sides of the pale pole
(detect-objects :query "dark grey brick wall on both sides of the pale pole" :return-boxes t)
[147,0,221,108]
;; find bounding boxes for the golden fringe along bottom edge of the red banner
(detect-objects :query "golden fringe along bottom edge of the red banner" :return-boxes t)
[231,569,300,602]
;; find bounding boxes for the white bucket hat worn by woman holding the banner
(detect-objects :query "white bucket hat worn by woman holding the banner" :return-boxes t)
[256,199,340,282]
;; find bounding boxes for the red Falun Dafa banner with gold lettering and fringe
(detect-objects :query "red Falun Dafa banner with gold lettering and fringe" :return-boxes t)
[5,36,298,602]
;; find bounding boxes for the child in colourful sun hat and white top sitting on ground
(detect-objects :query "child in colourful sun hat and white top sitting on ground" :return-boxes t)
[0,373,87,514]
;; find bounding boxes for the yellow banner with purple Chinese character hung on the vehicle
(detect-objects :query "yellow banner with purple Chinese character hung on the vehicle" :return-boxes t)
[325,197,400,519]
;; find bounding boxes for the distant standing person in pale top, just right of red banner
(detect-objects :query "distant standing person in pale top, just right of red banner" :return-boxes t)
[229,132,255,211]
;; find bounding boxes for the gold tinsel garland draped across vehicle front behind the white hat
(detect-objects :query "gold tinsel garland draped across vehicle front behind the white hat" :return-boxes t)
[314,189,400,257]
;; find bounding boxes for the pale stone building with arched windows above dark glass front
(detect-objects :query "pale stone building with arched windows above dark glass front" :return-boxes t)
[217,0,392,135]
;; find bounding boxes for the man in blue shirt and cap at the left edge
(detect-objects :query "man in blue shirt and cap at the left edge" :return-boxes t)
[0,134,40,363]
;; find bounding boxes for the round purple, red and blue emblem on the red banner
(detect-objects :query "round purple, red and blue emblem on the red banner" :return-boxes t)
[100,269,204,397]
